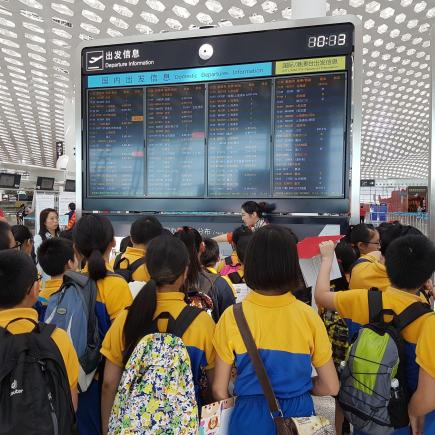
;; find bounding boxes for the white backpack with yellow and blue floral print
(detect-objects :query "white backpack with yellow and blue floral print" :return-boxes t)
[108,306,202,435]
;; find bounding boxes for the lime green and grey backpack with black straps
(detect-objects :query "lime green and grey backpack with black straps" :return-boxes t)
[338,288,431,435]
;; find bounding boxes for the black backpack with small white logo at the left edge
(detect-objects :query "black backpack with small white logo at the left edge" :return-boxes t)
[0,319,76,435]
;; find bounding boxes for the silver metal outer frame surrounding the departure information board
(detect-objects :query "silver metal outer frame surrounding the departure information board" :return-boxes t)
[74,16,362,220]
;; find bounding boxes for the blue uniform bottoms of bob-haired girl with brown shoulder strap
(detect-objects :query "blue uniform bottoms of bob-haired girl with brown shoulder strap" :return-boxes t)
[228,393,314,435]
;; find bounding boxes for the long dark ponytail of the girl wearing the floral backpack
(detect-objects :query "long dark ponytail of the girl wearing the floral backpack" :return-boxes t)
[123,279,157,365]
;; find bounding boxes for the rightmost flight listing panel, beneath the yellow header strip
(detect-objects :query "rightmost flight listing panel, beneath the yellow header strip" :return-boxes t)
[273,73,346,197]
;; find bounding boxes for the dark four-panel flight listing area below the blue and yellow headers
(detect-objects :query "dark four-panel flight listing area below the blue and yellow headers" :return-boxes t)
[88,73,346,198]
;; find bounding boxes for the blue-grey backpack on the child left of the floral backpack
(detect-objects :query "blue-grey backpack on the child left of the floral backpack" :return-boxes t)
[45,271,101,392]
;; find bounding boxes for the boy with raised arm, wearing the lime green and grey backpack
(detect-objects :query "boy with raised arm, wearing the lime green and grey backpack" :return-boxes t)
[315,235,435,434]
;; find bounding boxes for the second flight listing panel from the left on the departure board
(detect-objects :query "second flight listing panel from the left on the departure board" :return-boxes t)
[146,84,205,197]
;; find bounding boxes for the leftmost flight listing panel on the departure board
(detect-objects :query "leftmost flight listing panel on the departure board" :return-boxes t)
[87,88,145,197]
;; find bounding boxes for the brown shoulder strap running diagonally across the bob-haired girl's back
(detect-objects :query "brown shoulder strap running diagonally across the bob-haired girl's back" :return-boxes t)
[233,303,289,433]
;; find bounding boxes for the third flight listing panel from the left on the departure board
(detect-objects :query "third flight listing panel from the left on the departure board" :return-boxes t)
[208,80,271,197]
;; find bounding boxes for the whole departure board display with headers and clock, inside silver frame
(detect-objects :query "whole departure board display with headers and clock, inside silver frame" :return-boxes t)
[82,23,353,211]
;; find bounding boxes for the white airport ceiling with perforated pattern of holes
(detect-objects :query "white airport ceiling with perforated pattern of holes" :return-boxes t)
[0,0,435,178]
